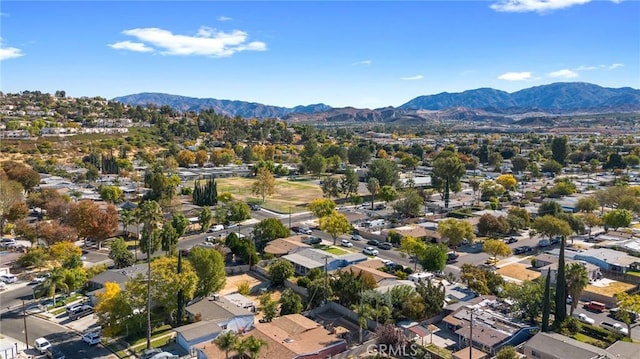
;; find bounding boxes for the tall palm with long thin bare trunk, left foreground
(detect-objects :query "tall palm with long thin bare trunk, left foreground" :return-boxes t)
[138,200,163,349]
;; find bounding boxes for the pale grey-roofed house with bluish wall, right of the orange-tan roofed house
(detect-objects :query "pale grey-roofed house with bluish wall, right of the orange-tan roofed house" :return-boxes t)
[282,248,367,275]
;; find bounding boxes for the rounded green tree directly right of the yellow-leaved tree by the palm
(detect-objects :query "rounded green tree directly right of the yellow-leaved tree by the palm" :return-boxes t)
[189,246,227,297]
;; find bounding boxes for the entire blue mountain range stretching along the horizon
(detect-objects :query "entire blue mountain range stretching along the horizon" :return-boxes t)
[113,82,640,123]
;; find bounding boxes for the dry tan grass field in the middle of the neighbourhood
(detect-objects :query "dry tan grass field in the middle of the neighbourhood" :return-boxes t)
[216,177,322,213]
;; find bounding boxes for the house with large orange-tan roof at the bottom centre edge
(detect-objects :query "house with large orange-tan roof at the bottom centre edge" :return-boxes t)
[197,314,347,359]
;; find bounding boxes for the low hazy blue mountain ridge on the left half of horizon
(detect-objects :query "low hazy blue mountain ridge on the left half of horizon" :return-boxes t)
[113,92,331,118]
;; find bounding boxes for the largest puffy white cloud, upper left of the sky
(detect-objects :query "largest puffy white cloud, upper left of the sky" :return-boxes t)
[110,26,267,57]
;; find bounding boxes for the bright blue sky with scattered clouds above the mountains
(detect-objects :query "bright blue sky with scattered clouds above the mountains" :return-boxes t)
[0,0,640,108]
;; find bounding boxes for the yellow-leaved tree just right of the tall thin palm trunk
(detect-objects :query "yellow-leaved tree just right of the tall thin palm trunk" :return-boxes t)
[151,257,198,322]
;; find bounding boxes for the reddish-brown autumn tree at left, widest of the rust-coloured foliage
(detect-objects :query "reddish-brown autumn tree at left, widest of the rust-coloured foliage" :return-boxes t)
[67,200,119,249]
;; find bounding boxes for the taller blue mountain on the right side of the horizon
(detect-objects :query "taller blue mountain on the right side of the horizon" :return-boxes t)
[400,82,640,113]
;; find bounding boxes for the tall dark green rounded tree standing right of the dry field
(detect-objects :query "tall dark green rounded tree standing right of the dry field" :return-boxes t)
[432,151,465,208]
